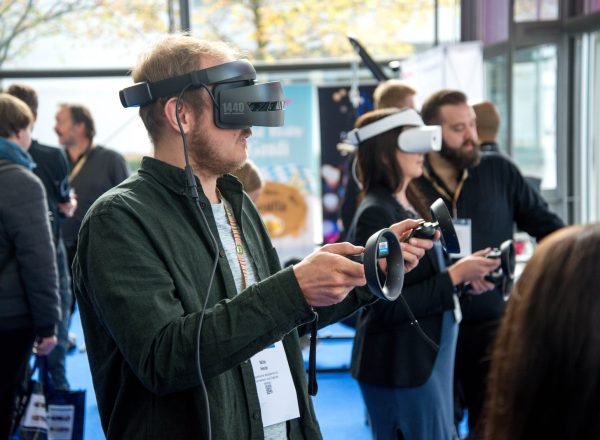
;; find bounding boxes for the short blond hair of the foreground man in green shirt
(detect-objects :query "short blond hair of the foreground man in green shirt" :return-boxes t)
[131,35,241,143]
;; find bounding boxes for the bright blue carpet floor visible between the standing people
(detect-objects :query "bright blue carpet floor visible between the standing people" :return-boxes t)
[67,313,371,440]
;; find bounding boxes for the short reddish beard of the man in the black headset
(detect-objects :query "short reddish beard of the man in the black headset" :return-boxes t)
[188,124,251,176]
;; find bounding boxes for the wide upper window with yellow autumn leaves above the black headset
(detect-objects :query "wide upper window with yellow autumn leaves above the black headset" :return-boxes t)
[191,0,460,63]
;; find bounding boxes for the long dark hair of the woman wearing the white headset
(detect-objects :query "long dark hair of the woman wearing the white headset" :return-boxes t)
[355,107,429,217]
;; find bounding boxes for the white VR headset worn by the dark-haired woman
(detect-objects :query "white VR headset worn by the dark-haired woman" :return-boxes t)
[338,108,442,153]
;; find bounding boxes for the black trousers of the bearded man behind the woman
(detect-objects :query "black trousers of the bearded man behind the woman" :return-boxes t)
[454,321,498,440]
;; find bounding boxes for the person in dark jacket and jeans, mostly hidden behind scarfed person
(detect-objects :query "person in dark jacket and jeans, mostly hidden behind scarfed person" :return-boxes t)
[7,84,77,390]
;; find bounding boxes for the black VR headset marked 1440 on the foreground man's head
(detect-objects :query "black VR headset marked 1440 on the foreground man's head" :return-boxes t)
[119,60,284,129]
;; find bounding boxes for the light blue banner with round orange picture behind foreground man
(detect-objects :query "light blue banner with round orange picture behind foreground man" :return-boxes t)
[248,84,321,264]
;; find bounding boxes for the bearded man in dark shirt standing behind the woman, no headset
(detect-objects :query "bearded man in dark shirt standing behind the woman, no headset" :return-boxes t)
[415,90,563,439]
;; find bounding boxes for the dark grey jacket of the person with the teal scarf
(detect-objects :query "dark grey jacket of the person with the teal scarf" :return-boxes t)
[0,160,60,337]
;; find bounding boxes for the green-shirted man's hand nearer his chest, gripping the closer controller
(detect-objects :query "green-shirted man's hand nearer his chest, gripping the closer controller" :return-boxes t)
[293,243,367,307]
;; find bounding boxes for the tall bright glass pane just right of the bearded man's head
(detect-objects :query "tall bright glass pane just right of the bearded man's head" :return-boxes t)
[512,45,557,190]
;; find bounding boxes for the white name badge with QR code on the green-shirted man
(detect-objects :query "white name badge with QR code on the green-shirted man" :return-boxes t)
[250,341,300,426]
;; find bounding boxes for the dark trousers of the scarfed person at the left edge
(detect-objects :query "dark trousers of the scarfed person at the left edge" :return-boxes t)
[0,328,35,440]
